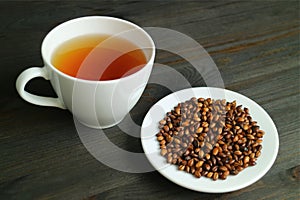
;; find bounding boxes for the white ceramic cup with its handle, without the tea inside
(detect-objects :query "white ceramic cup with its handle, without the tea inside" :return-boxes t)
[16,16,155,128]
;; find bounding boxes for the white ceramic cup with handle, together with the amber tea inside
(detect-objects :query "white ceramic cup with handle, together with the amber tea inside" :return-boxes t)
[16,16,155,128]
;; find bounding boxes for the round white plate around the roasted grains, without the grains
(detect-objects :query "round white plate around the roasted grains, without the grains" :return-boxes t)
[141,87,279,193]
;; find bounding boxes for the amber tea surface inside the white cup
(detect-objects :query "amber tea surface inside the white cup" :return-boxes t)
[51,35,147,81]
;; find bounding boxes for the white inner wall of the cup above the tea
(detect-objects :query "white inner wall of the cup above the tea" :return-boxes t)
[42,17,154,64]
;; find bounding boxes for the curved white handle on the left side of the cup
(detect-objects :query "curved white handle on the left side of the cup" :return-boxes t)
[16,67,66,109]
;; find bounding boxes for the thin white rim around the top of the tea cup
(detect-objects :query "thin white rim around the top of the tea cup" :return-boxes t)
[41,16,155,84]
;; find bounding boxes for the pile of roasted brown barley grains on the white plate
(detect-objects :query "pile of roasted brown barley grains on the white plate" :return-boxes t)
[156,97,264,180]
